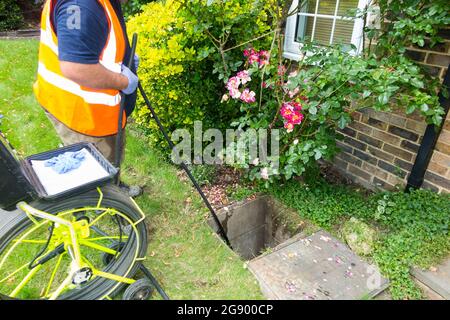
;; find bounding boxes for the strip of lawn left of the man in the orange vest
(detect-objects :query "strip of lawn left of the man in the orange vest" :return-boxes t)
[0,40,60,155]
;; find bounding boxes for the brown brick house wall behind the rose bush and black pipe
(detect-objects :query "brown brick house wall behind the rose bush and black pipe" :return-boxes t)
[334,29,450,193]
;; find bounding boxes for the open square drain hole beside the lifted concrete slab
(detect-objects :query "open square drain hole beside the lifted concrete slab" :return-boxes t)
[209,196,305,260]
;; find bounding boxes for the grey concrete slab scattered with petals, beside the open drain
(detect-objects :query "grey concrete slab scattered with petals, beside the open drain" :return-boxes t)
[248,230,388,300]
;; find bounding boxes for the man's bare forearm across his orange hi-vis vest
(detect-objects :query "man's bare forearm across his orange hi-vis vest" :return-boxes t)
[60,61,129,91]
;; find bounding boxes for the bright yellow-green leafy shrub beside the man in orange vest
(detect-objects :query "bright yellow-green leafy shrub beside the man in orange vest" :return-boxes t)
[128,0,266,146]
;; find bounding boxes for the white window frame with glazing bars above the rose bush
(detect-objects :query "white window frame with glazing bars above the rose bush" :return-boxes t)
[283,0,371,61]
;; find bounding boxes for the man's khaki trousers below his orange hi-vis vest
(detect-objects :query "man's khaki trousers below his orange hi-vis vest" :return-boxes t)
[45,111,125,164]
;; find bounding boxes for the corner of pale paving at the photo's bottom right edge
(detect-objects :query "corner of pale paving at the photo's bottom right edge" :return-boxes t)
[411,257,450,300]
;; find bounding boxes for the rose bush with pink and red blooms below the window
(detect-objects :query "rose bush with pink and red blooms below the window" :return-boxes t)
[222,45,443,184]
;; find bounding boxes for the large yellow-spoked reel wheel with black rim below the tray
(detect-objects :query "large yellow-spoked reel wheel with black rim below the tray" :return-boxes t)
[0,185,147,300]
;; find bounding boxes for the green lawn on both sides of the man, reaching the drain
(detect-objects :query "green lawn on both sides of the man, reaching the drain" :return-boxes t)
[0,40,262,299]
